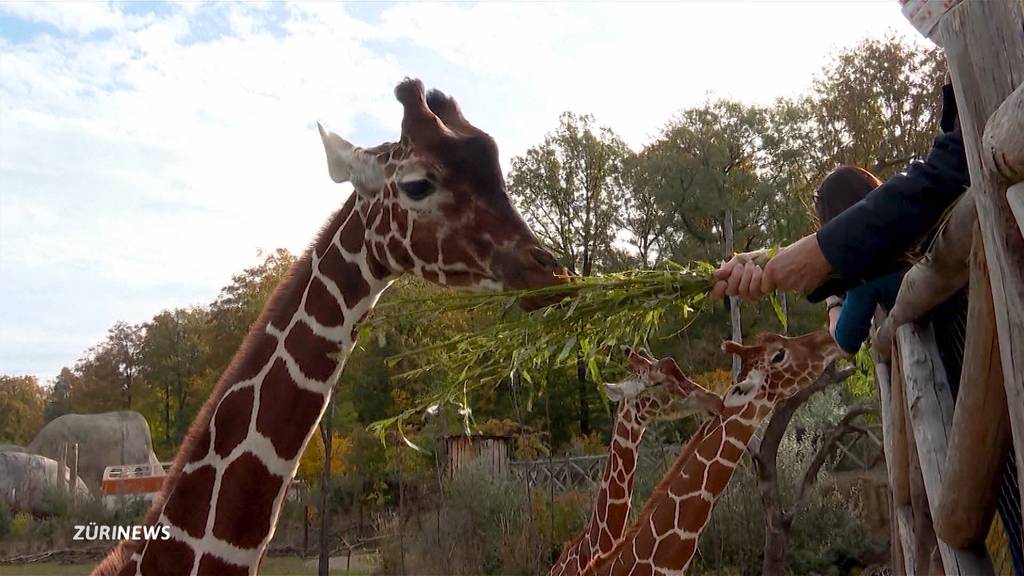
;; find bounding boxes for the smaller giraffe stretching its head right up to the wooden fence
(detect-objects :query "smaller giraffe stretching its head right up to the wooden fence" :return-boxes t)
[587,331,840,576]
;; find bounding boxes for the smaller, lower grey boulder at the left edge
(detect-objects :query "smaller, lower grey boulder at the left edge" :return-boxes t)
[0,450,90,513]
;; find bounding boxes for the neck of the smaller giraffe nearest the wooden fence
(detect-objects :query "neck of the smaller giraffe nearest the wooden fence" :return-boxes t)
[587,402,770,576]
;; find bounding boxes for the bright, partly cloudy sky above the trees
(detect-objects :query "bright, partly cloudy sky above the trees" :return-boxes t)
[0,0,925,382]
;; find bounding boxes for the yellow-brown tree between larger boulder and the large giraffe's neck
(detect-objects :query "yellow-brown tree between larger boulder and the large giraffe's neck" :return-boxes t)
[141,307,209,447]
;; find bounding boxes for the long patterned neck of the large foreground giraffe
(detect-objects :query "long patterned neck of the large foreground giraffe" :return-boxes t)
[95,193,392,576]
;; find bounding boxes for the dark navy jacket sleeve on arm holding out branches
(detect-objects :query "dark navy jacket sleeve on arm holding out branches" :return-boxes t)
[808,85,970,302]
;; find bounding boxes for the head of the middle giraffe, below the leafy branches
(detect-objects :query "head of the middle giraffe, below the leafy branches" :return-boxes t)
[605,347,723,421]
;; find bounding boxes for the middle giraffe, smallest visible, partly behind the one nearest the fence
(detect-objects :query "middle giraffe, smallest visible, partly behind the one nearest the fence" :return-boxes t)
[548,348,722,576]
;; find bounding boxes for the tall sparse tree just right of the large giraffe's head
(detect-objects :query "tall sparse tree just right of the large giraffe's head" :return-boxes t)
[508,112,630,435]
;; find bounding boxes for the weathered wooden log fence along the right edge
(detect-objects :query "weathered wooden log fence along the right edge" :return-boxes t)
[876,0,1024,576]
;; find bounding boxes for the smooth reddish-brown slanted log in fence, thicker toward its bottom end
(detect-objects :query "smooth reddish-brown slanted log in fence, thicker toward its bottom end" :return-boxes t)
[935,223,1013,547]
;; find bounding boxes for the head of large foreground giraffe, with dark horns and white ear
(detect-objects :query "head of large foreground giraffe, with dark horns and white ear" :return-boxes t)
[317,79,567,301]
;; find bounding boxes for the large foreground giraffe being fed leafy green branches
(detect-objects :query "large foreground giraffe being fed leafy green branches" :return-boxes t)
[93,78,568,576]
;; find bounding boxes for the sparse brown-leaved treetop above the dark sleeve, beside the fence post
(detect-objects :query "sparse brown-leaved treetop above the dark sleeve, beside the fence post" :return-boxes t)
[813,36,946,179]
